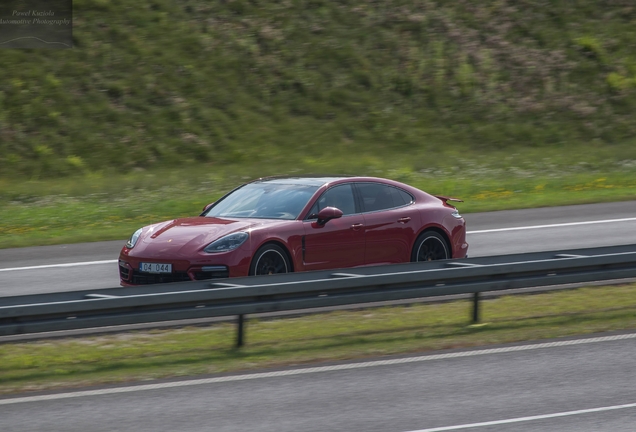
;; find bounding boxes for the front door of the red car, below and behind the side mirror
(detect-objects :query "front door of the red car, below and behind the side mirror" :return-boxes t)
[302,183,364,270]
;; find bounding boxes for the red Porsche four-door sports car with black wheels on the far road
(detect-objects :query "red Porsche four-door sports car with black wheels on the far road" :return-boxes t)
[119,177,468,285]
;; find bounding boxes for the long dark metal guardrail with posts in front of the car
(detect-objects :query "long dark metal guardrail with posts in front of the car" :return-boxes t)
[0,245,636,346]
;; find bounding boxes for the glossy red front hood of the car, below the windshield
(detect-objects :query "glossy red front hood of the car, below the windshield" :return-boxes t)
[129,217,266,258]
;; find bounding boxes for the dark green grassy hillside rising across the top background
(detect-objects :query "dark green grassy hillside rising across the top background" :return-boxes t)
[0,0,636,179]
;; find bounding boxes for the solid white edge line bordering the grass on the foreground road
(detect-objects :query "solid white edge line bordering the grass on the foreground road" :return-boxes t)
[0,333,636,404]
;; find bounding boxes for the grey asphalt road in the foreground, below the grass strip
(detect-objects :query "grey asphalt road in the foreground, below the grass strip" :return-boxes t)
[0,334,636,432]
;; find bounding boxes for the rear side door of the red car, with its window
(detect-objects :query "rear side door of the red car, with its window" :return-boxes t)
[356,182,420,265]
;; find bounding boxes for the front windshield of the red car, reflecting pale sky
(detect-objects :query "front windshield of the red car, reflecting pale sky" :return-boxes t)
[205,183,318,219]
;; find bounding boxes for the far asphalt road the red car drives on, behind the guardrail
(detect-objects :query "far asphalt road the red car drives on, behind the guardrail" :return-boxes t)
[0,201,636,296]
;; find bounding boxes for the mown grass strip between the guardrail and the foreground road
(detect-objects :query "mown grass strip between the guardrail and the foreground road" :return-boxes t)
[0,285,636,394]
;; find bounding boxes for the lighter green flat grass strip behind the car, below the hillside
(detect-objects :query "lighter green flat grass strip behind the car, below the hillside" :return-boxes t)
[0,148,636,248]
